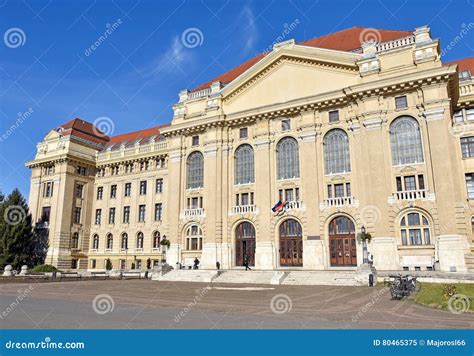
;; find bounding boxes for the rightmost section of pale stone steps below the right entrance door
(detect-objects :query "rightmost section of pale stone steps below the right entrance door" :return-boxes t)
[281,270,360,286]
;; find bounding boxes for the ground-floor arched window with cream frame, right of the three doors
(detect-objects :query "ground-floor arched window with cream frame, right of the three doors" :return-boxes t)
[400,211,431,245]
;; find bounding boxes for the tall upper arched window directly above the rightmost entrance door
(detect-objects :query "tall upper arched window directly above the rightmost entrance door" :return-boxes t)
[324,129,351,174]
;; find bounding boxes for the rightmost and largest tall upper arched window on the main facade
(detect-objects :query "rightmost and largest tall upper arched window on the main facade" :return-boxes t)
[390,116,423,165]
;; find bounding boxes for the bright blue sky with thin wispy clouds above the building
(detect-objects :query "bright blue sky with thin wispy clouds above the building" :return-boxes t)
[0,0,474,195]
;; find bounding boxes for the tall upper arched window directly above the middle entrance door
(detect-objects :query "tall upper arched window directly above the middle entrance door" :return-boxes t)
[277,137,300,179]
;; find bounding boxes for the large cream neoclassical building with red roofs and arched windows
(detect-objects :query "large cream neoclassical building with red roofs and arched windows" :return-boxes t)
[27,26,474,272]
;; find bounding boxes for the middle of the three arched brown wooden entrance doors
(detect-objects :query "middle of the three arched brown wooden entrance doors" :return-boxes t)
[280,219,303,267]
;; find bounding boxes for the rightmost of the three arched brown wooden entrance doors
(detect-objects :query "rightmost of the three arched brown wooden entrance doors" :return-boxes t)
[329,216,357,266]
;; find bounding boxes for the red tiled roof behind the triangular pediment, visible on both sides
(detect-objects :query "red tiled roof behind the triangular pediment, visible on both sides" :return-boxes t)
[192,27,413,91]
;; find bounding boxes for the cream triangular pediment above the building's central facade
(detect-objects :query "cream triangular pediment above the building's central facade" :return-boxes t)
[222,45,360,112]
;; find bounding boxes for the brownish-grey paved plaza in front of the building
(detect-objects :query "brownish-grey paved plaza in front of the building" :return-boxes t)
[0,280,474,329]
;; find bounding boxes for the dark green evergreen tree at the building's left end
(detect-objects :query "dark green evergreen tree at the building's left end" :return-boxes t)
[0,189,47,269]
